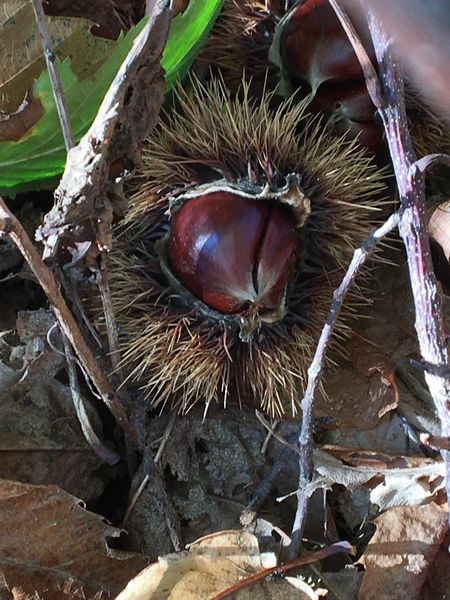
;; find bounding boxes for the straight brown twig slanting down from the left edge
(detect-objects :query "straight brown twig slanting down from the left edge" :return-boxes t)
[0,198,136,439]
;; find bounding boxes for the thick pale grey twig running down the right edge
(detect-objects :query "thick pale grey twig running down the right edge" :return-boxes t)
[329,0,450,519]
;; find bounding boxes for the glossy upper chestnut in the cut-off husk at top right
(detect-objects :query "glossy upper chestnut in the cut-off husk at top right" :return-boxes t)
[280,0,372,90]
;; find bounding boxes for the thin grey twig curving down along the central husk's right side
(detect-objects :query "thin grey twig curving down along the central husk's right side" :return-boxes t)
[289,213,400,558]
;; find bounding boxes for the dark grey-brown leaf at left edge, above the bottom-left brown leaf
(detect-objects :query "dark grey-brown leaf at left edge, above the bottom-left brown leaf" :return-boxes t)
[0,374,104,501]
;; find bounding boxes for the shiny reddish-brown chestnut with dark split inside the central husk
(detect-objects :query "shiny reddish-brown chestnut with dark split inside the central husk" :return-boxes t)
[168,191,298,314]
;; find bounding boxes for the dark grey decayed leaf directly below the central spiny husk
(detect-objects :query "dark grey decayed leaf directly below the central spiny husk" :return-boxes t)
[122,406,267,561]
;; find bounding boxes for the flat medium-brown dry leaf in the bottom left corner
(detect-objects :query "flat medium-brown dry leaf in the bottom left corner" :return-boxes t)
[0,480,145,600]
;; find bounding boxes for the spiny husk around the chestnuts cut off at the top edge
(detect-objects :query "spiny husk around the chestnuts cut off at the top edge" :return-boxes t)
[202,0,450,157]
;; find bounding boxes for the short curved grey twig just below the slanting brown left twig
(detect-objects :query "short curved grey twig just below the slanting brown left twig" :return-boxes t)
[62,335,120,465]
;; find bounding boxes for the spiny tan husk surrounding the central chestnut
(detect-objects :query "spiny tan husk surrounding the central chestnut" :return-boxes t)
[110,80,384,417]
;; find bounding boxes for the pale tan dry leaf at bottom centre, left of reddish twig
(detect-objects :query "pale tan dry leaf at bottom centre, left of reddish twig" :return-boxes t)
[116,531,276,600]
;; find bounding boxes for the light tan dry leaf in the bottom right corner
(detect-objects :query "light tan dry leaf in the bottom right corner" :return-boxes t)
[359,503,447,600]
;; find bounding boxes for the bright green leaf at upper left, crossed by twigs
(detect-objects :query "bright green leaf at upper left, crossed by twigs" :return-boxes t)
[0,0,223,196]
